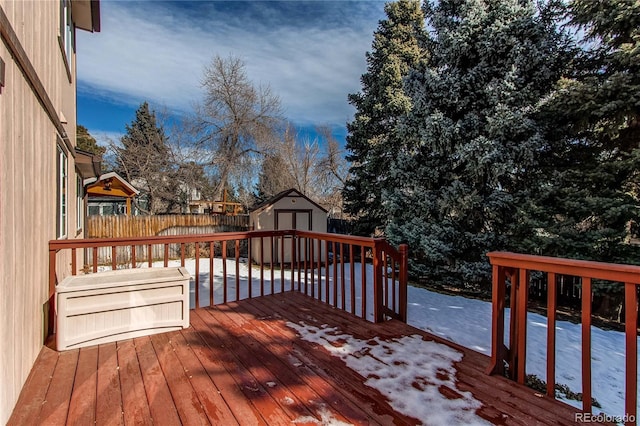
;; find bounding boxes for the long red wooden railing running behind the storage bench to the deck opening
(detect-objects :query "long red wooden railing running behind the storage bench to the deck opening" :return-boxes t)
[49,230,408,332]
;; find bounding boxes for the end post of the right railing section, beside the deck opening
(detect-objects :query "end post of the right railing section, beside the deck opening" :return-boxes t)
[486,265,504,375]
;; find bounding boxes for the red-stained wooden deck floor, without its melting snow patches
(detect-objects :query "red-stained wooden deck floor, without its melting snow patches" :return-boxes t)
[8,292,596,425]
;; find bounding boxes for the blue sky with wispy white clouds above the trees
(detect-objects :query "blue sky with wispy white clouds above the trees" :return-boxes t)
[77,0,385,145]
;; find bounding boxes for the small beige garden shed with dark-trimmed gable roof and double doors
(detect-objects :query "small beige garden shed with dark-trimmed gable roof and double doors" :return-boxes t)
[249,189,327,263]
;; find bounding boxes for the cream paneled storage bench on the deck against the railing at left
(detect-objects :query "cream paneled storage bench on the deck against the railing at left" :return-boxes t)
[56,268,190,351]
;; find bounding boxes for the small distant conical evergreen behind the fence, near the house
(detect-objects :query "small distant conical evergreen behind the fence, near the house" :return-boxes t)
[116,102,180,214]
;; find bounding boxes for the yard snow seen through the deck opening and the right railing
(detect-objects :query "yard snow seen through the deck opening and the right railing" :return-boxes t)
[407,286,640,416]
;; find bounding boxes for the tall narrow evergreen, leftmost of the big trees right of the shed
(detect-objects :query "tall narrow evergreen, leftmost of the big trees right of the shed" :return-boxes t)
[343,0,426,235]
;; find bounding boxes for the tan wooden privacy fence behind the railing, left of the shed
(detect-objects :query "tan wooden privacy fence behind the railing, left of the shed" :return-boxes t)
[87,215,249,264]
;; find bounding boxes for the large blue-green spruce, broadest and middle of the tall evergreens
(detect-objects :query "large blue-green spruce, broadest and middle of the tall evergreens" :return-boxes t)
[383,0,566,288]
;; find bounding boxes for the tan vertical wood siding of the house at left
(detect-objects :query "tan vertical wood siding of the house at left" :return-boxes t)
[0,0,82,424]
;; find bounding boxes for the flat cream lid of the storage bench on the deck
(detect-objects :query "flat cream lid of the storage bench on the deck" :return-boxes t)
[56,267,191,293]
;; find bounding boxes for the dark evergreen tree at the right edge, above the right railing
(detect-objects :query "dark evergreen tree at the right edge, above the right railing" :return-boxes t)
[524,0,640,263]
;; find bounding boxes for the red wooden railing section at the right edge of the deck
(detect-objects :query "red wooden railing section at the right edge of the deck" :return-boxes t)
[488,252,640,423]
